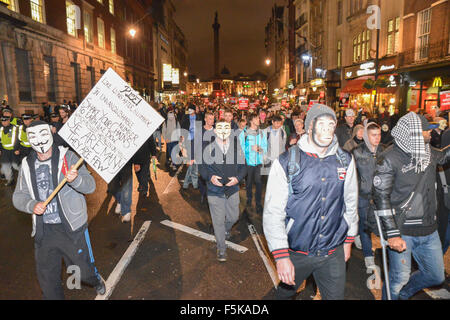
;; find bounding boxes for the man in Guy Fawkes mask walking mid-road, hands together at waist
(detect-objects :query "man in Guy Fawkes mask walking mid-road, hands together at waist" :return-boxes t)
[199,122,247,262]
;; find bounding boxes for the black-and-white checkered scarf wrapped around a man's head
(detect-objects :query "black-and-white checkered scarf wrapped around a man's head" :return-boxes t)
[391,112,431,173]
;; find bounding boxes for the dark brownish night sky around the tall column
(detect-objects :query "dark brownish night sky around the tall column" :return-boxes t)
[172,0,284,79]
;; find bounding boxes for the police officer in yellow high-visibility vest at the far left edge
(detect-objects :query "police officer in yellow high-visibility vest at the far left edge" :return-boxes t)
[0,116,19,186]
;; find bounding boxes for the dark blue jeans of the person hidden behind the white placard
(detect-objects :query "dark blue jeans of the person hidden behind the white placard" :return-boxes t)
[108,163,133,216]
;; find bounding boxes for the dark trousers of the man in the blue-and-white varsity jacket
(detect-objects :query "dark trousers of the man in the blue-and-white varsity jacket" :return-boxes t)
[276,246,345,300]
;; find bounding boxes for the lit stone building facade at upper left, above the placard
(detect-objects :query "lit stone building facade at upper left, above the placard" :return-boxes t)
[0,0,154,114]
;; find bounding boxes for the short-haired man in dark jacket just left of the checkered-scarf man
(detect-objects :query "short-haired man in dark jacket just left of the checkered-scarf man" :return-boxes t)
[352,122,386,269]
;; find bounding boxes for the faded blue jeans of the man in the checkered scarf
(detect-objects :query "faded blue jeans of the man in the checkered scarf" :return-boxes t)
[383,231,445,300]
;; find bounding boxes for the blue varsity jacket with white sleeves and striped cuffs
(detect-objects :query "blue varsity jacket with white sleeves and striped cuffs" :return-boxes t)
[263,135,358,260]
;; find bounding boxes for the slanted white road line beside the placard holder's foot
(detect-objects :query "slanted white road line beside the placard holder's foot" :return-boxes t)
[95,221,151,300]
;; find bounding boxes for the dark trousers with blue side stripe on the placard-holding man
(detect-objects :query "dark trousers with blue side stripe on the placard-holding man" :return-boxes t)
[34,224,100,300]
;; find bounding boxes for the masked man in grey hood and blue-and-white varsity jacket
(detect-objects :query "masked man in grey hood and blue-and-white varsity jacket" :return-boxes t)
[263,104,358,300]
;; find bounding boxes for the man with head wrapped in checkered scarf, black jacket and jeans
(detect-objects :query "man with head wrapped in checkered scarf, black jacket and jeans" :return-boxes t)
[373,112,450,300]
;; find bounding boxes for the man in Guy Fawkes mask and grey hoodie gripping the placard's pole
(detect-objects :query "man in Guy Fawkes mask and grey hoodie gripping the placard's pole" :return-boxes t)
[13,121,106,300]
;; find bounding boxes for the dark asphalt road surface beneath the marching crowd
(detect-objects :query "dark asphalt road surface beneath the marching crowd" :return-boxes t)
[0,148,450,300]
